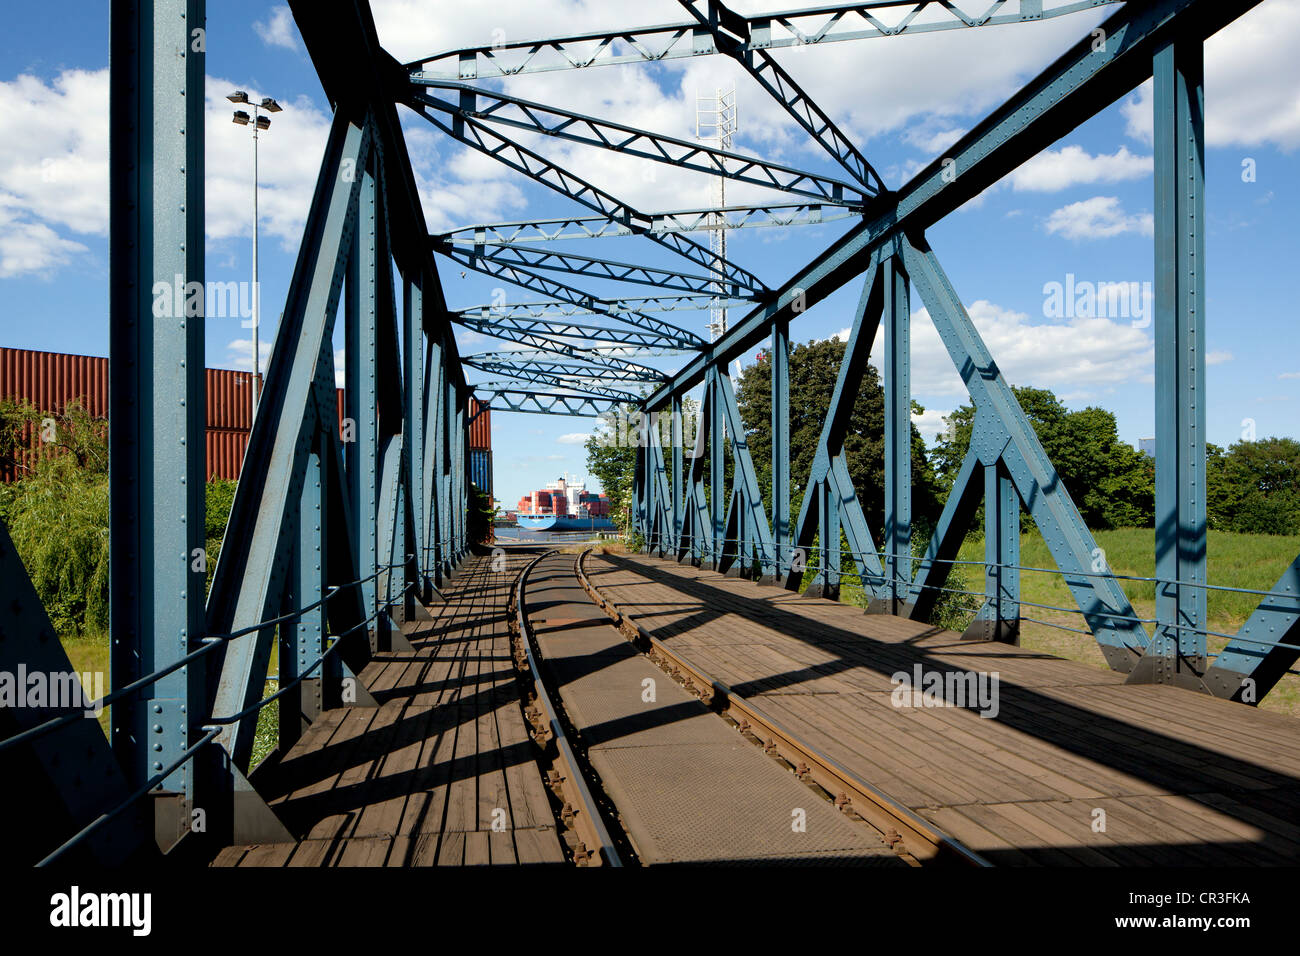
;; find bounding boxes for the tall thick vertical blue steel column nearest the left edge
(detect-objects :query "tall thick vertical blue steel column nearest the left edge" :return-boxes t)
[109,0,208,844]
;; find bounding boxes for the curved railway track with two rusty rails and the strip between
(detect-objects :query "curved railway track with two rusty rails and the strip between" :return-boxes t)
[512,551,984,866]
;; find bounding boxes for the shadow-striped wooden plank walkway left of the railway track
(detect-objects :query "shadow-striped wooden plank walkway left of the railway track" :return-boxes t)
[215,554,564,866]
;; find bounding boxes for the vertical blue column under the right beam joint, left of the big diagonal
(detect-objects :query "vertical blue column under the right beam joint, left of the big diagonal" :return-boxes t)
[881,256,911,614]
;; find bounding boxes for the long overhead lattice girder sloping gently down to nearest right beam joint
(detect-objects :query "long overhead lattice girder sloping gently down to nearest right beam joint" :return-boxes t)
[413,82,867,206]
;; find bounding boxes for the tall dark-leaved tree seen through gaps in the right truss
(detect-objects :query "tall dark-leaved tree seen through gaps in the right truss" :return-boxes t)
[736,339,940,536]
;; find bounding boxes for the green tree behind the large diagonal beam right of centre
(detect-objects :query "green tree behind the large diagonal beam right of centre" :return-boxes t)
[933,386,1156,529]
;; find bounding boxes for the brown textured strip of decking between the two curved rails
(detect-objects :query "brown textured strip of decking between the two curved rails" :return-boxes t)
[524,554,906,868]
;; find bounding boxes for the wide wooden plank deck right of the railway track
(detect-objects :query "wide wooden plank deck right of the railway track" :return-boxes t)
[586,554,1300,866]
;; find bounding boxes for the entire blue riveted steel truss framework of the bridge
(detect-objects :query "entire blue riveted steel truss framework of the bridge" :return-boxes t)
[0,0,1300,861]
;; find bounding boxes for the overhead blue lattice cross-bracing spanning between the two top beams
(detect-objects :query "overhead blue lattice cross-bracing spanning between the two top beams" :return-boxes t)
[404,0,1128,416]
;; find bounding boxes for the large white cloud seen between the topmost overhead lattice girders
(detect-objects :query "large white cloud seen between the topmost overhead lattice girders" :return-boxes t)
[372,0,1104,208]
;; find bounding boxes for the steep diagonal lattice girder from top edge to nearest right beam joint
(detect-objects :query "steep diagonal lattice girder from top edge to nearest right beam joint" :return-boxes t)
[680,0,885,196]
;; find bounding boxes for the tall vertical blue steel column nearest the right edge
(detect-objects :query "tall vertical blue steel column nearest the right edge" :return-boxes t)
[1130,31,1206,689]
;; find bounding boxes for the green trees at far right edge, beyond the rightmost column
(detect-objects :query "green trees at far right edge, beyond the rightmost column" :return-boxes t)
[1206,438,1300,535]
